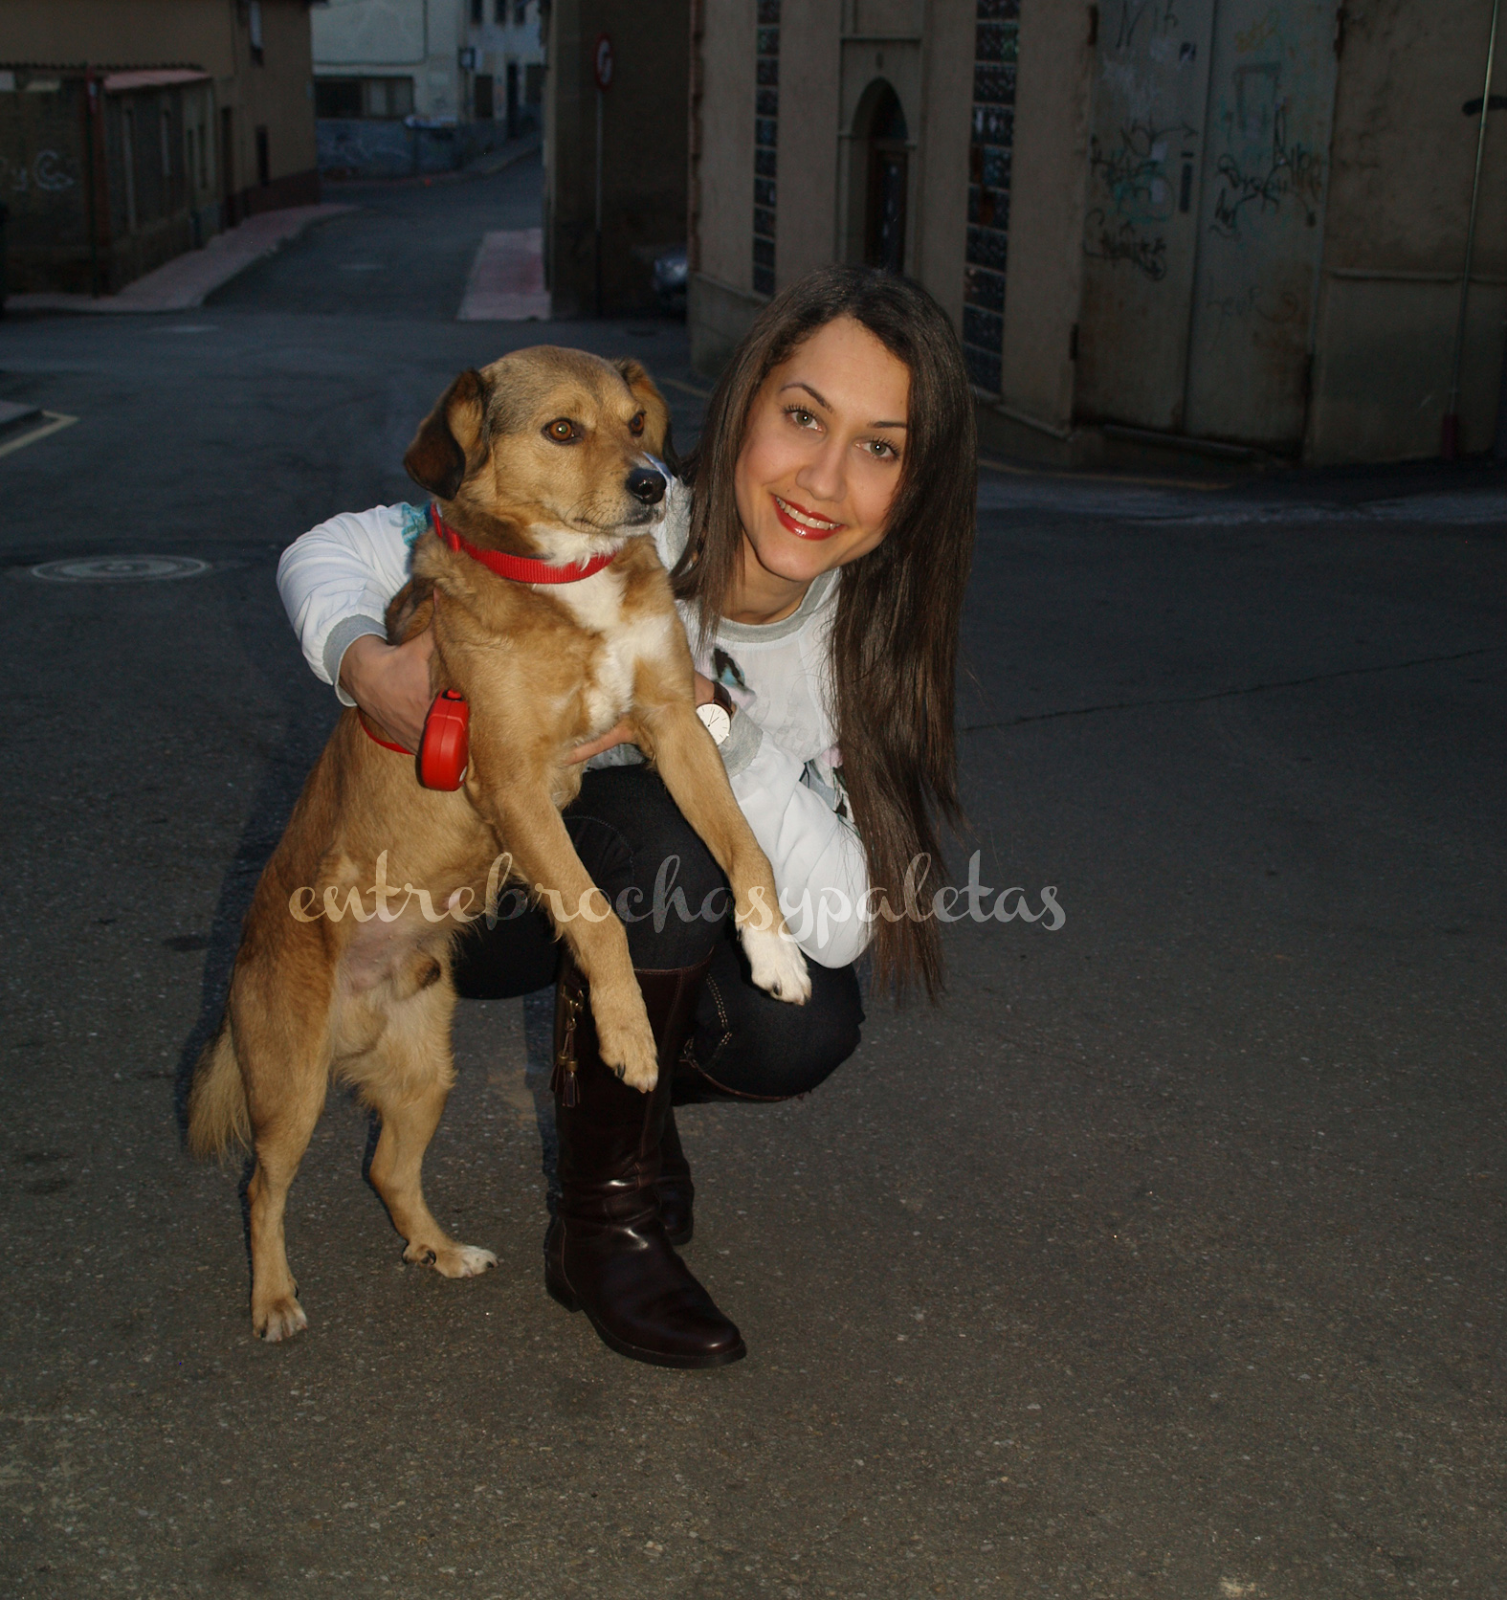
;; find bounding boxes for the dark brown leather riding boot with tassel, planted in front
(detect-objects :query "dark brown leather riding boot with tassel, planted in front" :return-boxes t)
[544,958,747,1366]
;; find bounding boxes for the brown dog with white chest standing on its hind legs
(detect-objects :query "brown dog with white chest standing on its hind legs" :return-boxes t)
[189,347,811,1339]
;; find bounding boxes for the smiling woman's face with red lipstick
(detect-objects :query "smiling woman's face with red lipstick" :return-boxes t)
[736,317,910,584]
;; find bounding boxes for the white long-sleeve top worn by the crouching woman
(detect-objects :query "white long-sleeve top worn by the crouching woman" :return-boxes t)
[277,480,870,966]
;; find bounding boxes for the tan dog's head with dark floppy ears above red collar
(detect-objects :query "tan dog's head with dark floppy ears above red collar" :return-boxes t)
[403,344,670,560]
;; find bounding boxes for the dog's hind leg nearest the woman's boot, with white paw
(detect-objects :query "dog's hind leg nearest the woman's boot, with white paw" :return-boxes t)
[349,960,498,1278]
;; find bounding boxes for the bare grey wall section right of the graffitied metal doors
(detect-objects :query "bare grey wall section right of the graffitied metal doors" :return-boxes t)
[1305,0,1507,461]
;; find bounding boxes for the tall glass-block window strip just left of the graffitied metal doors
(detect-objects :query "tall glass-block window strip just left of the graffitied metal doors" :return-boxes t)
[963,0,1021,395]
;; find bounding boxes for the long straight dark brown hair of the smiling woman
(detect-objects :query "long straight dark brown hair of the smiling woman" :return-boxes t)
[672,267,977,1000]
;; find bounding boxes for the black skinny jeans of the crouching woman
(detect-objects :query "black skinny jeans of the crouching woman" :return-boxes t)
[454,766,864,1104]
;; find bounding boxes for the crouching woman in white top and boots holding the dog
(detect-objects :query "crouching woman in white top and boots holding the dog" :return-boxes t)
[278,267,976,1366]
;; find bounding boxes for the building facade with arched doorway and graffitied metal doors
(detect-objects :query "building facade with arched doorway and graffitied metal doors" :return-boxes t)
[690,0,1507,462]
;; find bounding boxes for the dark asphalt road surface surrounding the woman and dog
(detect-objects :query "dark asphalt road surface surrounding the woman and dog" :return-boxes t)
[0,166,1507,1600]
